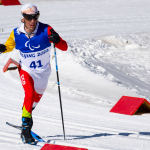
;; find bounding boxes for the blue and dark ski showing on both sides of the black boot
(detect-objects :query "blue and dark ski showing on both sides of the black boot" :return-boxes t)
[6,122,46,146]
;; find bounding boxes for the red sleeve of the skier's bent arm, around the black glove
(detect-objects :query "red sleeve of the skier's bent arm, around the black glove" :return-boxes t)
[48,26,68,51]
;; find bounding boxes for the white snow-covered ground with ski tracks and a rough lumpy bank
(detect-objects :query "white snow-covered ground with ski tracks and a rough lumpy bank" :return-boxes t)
[0,0,150,150]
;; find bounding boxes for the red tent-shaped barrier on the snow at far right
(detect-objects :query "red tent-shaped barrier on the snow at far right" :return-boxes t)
[110,96,150,115]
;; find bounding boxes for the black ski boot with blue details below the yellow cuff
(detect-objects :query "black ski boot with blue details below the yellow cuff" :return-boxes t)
[21,117,35,145]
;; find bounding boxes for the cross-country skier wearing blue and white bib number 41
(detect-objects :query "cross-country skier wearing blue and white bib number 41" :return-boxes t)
[0,4,68,144]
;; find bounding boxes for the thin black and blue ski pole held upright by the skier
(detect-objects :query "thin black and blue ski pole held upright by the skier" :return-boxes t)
[54,43,66,140]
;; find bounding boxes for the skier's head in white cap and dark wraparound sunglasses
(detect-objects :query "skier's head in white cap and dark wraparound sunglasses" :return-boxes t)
[21,3,40,32]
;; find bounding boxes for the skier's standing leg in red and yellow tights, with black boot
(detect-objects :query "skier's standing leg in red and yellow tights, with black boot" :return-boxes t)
[19,69,35,143]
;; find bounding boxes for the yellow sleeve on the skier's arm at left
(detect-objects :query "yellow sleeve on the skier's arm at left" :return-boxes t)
[4,30,16,53]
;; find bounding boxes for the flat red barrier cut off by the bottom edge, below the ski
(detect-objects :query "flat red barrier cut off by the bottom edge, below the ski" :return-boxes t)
[41,144,88,150]
